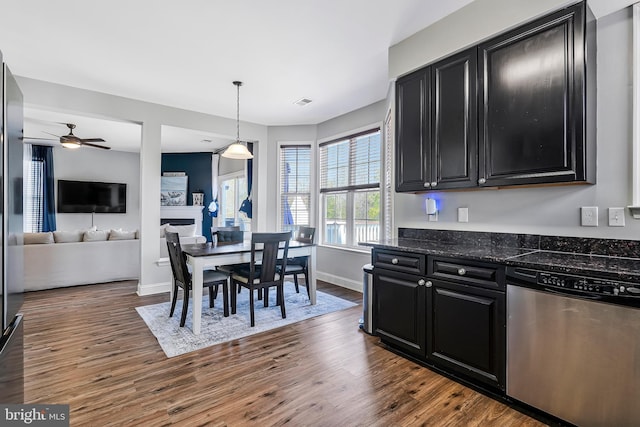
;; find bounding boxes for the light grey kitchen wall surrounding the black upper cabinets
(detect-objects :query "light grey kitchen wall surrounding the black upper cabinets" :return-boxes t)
[390,0,640,239]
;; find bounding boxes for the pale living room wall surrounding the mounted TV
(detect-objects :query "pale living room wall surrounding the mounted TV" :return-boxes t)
[53,147,140,234]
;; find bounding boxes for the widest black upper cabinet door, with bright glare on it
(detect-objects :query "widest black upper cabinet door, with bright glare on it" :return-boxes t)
[479,4,595,186]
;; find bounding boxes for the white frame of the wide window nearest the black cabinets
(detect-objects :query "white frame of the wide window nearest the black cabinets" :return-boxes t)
[317,123,388,252]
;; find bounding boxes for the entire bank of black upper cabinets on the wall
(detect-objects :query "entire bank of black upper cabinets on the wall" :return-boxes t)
[396,2,596,192]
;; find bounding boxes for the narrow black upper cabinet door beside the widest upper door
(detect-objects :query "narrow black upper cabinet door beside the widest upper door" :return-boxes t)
[431,47,478,189]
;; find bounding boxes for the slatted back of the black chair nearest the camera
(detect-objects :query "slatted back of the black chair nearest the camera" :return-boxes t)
[250,232,291,282]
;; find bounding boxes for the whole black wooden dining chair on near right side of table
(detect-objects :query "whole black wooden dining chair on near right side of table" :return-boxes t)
[231,232,291,327]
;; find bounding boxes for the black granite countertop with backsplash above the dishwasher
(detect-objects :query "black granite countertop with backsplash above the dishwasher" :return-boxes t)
[362,228,640,282]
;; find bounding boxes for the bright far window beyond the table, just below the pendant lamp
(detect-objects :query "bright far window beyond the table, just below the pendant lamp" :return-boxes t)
[217,173,251,231]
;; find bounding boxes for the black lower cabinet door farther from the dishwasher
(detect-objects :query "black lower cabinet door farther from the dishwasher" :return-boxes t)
[373,268,426,358]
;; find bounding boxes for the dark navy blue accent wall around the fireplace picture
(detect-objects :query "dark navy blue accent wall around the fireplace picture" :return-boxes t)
[160,153,212,241]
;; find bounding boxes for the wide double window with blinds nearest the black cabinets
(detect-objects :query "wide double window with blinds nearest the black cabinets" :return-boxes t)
[320,129,381,246]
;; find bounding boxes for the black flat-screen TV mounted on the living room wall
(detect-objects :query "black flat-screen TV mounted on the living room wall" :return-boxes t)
[58,179,127,213]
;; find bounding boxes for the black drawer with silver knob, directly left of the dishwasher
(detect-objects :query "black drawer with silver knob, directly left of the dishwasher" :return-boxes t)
[429,257,505,291]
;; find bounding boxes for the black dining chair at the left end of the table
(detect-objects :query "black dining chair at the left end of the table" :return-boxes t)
[166,231,229,327]
